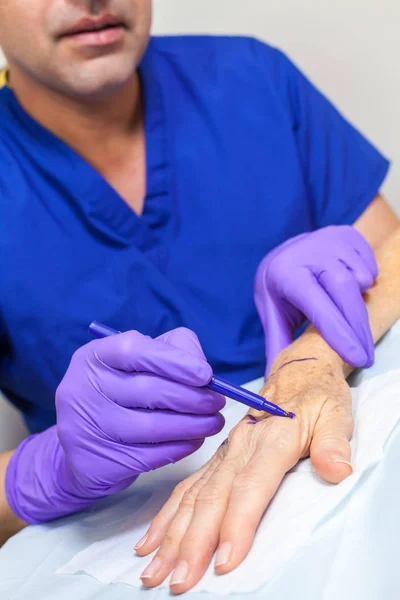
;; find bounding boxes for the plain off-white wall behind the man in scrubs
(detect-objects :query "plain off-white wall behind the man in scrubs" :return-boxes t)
[0,0,400,448]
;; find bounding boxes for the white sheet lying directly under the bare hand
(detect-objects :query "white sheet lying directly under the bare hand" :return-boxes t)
[58,369,400,595]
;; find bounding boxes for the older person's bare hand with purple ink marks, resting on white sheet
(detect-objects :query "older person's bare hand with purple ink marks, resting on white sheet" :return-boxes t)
[136,338,353,593]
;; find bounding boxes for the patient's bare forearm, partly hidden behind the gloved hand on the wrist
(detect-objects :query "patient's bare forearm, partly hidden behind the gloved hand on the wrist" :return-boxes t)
[272,228,400,376]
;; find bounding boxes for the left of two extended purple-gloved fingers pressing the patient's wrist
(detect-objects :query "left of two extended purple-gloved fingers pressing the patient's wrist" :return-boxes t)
[286,269,367,367]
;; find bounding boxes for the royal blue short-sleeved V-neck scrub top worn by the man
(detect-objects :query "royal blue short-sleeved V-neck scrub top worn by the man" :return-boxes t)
[0,37,388,432]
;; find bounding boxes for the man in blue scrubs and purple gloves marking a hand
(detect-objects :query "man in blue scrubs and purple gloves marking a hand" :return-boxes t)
[0,0,397,539]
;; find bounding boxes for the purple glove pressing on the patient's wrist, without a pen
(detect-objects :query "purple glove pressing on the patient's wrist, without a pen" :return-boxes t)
[255,226,378,374]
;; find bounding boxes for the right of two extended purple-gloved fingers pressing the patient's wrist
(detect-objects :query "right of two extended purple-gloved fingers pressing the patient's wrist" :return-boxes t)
[318,262,374,367]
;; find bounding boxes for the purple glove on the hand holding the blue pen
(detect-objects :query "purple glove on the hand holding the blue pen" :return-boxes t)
[6,328,225,523]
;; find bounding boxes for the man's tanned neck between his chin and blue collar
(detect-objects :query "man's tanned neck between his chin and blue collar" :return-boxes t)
[9,67,143,156]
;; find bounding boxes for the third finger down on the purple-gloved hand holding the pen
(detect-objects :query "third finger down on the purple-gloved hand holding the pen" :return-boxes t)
[103,407,225,444]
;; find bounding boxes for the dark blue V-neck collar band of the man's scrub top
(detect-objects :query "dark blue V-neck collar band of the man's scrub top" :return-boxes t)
[3,37,171,251]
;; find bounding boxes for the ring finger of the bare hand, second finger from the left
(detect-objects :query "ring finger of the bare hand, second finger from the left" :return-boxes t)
[141,460,223,587]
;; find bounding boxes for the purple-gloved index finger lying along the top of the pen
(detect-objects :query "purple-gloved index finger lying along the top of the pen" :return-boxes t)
[93,331,212,386]
